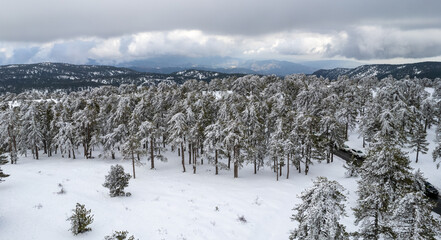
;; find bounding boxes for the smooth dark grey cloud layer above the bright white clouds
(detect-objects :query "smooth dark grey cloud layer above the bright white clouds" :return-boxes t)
[0,0,441,41]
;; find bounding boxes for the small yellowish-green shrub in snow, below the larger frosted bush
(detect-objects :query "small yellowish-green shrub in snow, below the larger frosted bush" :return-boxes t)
[67,203,93,235]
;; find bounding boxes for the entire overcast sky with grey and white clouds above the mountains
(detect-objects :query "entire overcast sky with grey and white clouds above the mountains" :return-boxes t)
[0,0,441,64]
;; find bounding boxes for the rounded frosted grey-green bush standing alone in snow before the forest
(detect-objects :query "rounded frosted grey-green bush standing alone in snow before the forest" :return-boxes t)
[103,164,132,197]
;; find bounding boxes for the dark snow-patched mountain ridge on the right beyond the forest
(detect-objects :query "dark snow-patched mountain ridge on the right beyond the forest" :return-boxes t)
[313,62,441,79]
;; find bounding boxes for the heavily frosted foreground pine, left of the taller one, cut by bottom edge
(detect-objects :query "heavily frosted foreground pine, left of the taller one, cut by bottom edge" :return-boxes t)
[289,177,349,240]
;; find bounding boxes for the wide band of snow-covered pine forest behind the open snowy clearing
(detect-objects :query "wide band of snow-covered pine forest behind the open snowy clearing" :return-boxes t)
[0,75,441,179]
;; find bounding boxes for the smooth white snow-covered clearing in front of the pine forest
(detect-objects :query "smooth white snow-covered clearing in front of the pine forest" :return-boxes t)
[0,129,441,240]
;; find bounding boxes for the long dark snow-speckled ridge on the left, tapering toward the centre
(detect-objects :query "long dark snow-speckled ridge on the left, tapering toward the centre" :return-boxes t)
[0,63,243,93]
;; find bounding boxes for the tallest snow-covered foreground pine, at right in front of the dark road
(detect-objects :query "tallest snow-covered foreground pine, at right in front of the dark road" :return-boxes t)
[353,143,413,239]
